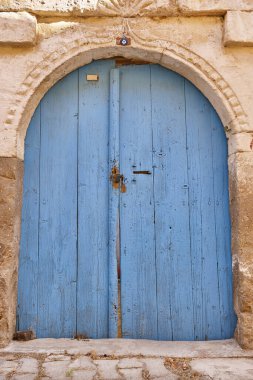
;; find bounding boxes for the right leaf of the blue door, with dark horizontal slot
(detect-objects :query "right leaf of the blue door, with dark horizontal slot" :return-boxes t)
[119,65,235,340]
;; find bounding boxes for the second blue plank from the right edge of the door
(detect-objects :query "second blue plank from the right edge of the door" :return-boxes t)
[185,81,221,340]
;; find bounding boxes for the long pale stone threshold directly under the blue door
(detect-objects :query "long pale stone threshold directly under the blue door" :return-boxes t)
[0,338,253,358]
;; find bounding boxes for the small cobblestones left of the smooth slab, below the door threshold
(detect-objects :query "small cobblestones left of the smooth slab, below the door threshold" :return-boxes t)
[0,353,179,380]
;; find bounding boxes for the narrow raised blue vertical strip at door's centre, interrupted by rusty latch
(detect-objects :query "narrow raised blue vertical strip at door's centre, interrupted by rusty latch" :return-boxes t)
[109,69,120,338]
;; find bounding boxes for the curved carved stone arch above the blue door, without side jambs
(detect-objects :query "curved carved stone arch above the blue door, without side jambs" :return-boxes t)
[5,29,248,159]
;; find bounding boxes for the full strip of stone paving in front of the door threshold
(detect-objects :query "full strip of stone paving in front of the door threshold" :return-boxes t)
[0,352,253,380]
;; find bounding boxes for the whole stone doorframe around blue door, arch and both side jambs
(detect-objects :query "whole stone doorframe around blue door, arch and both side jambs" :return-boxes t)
[0,37,253,347]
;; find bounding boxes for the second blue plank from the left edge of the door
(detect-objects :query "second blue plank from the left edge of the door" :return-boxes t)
[38,71,78,338]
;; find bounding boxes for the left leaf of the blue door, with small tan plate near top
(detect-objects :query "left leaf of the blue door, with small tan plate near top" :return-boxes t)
[17,61,114,338]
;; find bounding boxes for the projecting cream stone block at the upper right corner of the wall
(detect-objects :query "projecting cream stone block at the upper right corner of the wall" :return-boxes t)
[224,12,253,46]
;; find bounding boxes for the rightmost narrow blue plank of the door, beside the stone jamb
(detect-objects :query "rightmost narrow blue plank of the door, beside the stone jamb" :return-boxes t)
[211,108,236,339]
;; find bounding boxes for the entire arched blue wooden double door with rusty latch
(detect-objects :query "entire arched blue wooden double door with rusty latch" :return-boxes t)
[17,60,235,340]
